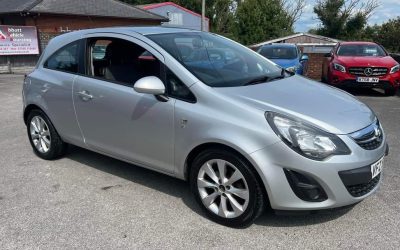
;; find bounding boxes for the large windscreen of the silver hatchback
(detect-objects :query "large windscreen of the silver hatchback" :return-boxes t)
[147,32,282,87]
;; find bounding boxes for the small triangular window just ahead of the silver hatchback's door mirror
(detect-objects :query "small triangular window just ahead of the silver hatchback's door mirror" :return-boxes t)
[166,68,196,103]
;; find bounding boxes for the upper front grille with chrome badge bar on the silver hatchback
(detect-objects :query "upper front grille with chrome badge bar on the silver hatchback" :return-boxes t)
[350,120,383,150]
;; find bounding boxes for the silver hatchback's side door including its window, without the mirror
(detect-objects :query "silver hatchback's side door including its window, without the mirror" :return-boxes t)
[73,33,175,173]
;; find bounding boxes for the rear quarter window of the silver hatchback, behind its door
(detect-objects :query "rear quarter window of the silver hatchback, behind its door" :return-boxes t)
[44,42,79,73]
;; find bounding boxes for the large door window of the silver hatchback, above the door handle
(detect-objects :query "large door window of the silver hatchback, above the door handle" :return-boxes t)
[88,38,161,86]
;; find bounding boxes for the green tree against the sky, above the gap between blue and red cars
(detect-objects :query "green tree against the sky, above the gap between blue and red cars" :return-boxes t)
[314,0,379,39]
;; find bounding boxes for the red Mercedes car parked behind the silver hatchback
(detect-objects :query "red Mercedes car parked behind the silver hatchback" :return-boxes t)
[322,42,400,95]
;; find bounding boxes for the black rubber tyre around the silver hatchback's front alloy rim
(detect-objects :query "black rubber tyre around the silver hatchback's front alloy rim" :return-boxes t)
[190,150,264,227]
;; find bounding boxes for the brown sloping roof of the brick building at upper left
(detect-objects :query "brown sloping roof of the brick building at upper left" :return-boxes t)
[0,0,168,21]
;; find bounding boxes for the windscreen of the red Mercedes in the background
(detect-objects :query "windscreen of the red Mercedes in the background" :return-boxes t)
[337,44,386,56]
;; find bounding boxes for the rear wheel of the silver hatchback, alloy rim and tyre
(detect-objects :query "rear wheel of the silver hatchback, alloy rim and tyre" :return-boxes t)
[27,110,67,160]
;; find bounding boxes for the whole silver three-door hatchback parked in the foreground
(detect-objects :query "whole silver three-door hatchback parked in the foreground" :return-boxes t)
[23,27,388,227]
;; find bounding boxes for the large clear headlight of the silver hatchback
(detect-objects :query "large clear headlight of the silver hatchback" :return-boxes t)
[265,112,350,161]
